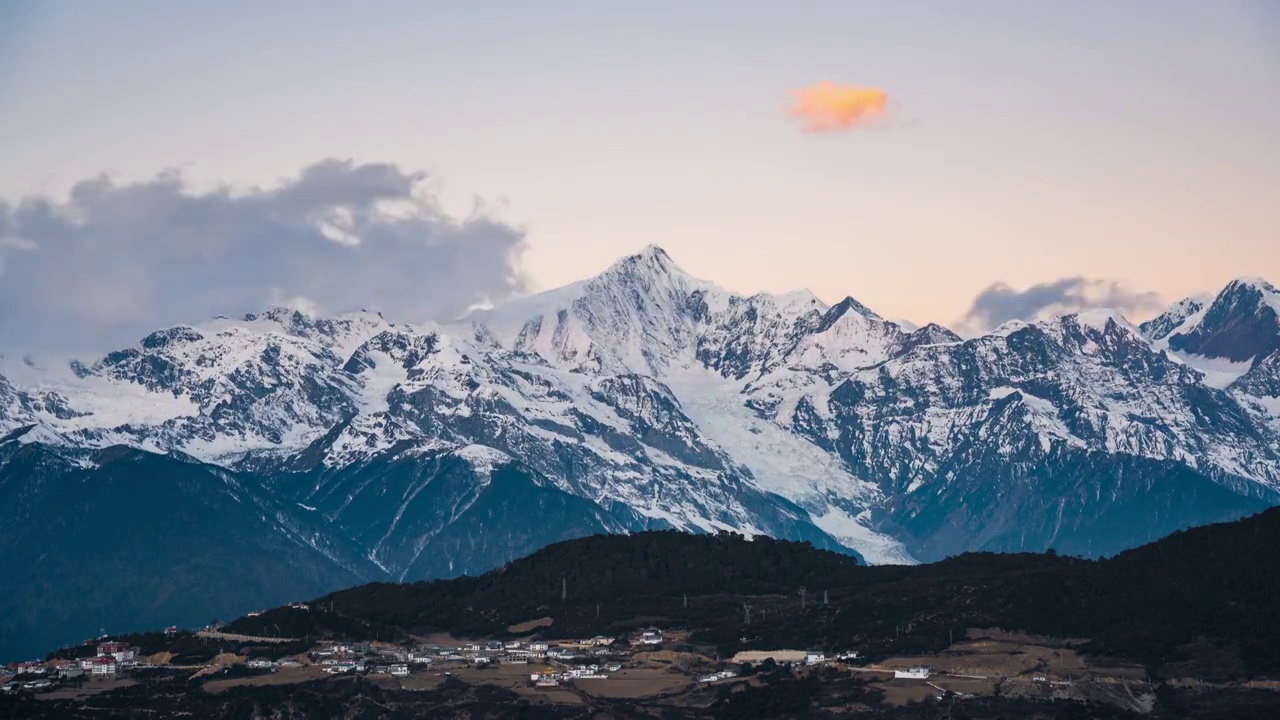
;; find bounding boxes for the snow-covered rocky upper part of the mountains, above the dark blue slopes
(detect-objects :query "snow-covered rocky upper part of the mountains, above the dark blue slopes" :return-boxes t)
[0,247,1280,562]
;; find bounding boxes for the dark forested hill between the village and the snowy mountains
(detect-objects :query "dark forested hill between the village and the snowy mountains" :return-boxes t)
[232,509,1280,678]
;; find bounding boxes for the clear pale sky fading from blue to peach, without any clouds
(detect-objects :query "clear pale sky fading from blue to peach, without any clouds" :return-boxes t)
[0,0,1280,348]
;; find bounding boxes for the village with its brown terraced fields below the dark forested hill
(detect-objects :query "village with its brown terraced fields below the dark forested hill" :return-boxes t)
[0,626,1167,703]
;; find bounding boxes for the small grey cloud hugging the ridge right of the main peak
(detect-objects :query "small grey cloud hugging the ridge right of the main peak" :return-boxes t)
[959,277,1162,332]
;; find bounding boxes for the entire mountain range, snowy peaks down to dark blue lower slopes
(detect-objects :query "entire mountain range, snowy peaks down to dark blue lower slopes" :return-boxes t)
[0,247,1280,657]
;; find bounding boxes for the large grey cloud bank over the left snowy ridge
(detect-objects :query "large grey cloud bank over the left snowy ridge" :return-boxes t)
[0,159,527,351]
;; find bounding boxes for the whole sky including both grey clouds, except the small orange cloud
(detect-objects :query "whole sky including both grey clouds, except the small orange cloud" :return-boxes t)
[0,0,1280,347]
